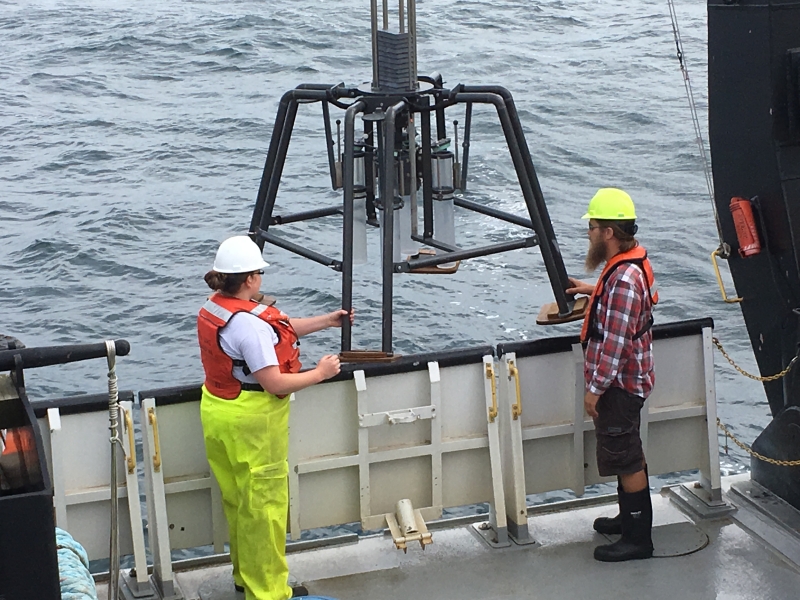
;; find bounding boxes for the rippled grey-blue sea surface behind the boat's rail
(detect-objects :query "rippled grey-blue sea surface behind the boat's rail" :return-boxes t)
[0,0,769,478]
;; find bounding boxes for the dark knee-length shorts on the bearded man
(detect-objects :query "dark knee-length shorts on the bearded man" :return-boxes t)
[594,387,644,477]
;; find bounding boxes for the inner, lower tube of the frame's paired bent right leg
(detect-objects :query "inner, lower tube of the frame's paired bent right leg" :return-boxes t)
[454,92,574,315]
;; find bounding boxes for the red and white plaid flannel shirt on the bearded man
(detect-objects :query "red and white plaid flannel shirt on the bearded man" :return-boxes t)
[584,264,655,398]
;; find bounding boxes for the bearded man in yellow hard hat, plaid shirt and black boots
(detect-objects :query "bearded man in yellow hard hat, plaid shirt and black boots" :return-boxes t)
[567,188,658,562]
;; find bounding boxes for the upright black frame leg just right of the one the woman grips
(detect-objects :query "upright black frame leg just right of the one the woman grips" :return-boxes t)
[381,101,405,353]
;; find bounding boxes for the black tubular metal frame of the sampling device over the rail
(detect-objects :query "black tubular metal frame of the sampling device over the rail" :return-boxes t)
[250,78,574,353]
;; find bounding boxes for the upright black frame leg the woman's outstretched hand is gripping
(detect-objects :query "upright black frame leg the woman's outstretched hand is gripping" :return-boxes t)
[341,100,366,352]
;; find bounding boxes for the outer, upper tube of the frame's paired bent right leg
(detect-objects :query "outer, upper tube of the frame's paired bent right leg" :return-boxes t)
[463,85,574,314]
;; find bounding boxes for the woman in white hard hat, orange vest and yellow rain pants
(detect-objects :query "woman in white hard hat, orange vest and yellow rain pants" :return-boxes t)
[197,236,353,600]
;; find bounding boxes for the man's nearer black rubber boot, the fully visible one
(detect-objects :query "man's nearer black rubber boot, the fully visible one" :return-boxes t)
[594,487,653,562]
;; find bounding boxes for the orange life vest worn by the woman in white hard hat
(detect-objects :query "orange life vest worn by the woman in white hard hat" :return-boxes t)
[197,293,301,400]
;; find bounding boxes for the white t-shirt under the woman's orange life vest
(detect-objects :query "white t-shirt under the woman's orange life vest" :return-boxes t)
[219,312,278,383]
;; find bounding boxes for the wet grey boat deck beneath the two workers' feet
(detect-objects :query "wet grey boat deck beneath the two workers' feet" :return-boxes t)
[99,479,800,600]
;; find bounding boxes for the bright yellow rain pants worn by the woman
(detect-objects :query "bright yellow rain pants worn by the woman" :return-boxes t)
[200,386,292,600]
